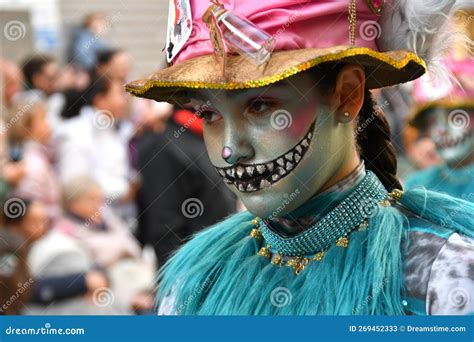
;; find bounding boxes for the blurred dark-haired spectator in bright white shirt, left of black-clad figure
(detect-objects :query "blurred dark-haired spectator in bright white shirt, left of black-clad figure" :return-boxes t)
[56,78,138,214]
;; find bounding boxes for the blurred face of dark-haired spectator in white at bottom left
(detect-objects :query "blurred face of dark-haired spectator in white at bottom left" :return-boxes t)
[12,202,48,242]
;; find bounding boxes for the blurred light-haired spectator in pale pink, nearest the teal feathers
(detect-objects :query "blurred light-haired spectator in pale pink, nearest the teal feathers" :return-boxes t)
[56,176,154,309]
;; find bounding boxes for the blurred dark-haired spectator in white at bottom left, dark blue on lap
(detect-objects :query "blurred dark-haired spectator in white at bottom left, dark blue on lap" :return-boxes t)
[5,198,127,315]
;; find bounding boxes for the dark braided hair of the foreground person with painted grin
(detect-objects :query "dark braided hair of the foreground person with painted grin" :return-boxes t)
[314,63,402,191]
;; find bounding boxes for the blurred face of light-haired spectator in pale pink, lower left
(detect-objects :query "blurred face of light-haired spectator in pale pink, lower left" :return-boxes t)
[67,186,104,224]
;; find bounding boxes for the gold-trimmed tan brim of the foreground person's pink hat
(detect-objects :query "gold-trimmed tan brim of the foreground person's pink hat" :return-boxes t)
[125,46,426,104]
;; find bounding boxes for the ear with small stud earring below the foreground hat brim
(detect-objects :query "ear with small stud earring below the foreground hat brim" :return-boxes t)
[332,64,365,123]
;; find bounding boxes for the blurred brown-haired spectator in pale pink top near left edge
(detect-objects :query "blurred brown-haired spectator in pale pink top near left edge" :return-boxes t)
[7,92,61,219]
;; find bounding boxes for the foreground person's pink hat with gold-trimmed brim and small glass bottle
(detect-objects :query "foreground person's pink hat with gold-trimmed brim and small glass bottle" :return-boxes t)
[126,0,453,103]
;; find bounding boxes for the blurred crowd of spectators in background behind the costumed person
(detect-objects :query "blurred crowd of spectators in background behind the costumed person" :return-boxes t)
[0,9,474,314]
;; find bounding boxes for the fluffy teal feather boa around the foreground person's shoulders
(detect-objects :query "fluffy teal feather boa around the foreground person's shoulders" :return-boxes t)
[158,189,474,315]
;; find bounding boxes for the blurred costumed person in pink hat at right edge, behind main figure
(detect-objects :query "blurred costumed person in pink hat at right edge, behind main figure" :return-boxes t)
[405,11,474,202]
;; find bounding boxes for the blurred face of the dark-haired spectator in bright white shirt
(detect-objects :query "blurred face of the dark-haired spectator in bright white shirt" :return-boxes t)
[94,81,128,120]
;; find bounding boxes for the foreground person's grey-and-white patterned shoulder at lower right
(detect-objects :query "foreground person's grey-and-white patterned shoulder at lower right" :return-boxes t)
[404,210,474,315]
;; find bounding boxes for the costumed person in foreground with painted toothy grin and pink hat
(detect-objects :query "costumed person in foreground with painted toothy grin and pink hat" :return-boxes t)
[126,0,474,315]
